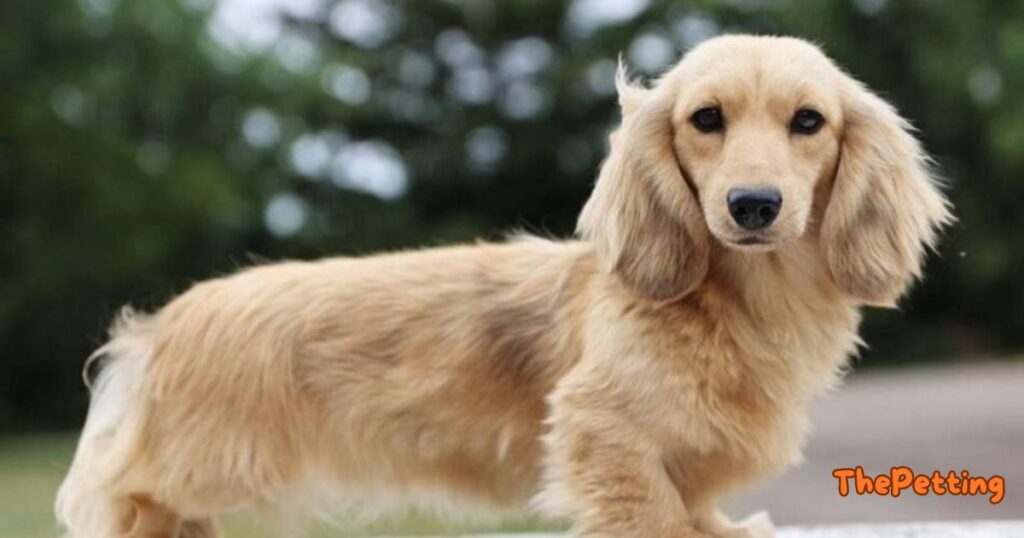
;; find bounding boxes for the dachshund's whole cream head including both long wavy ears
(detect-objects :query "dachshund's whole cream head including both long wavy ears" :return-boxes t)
[579,36,951,305]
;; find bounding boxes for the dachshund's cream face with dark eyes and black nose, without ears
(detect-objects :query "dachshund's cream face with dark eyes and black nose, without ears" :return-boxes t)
[672,39,843,251]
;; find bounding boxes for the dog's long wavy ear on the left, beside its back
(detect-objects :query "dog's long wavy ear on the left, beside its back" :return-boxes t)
[577,66,710,301]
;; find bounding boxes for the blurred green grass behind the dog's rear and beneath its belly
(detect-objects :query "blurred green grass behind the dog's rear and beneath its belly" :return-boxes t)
[0,434,550,538]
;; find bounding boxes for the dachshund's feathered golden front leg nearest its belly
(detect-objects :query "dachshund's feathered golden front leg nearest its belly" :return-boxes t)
[539,385,708,538]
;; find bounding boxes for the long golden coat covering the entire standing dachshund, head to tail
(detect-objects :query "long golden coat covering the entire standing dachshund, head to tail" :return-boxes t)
[57,36,950,538]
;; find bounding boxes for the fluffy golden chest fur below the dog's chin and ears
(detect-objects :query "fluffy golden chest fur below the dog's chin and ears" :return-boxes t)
[614,244,859,474]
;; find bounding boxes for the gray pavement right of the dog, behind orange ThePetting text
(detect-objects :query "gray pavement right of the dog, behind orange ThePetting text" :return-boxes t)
[728,361,1024,524]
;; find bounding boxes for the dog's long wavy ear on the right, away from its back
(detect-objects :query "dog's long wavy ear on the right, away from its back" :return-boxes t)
[821,80,952,306]
